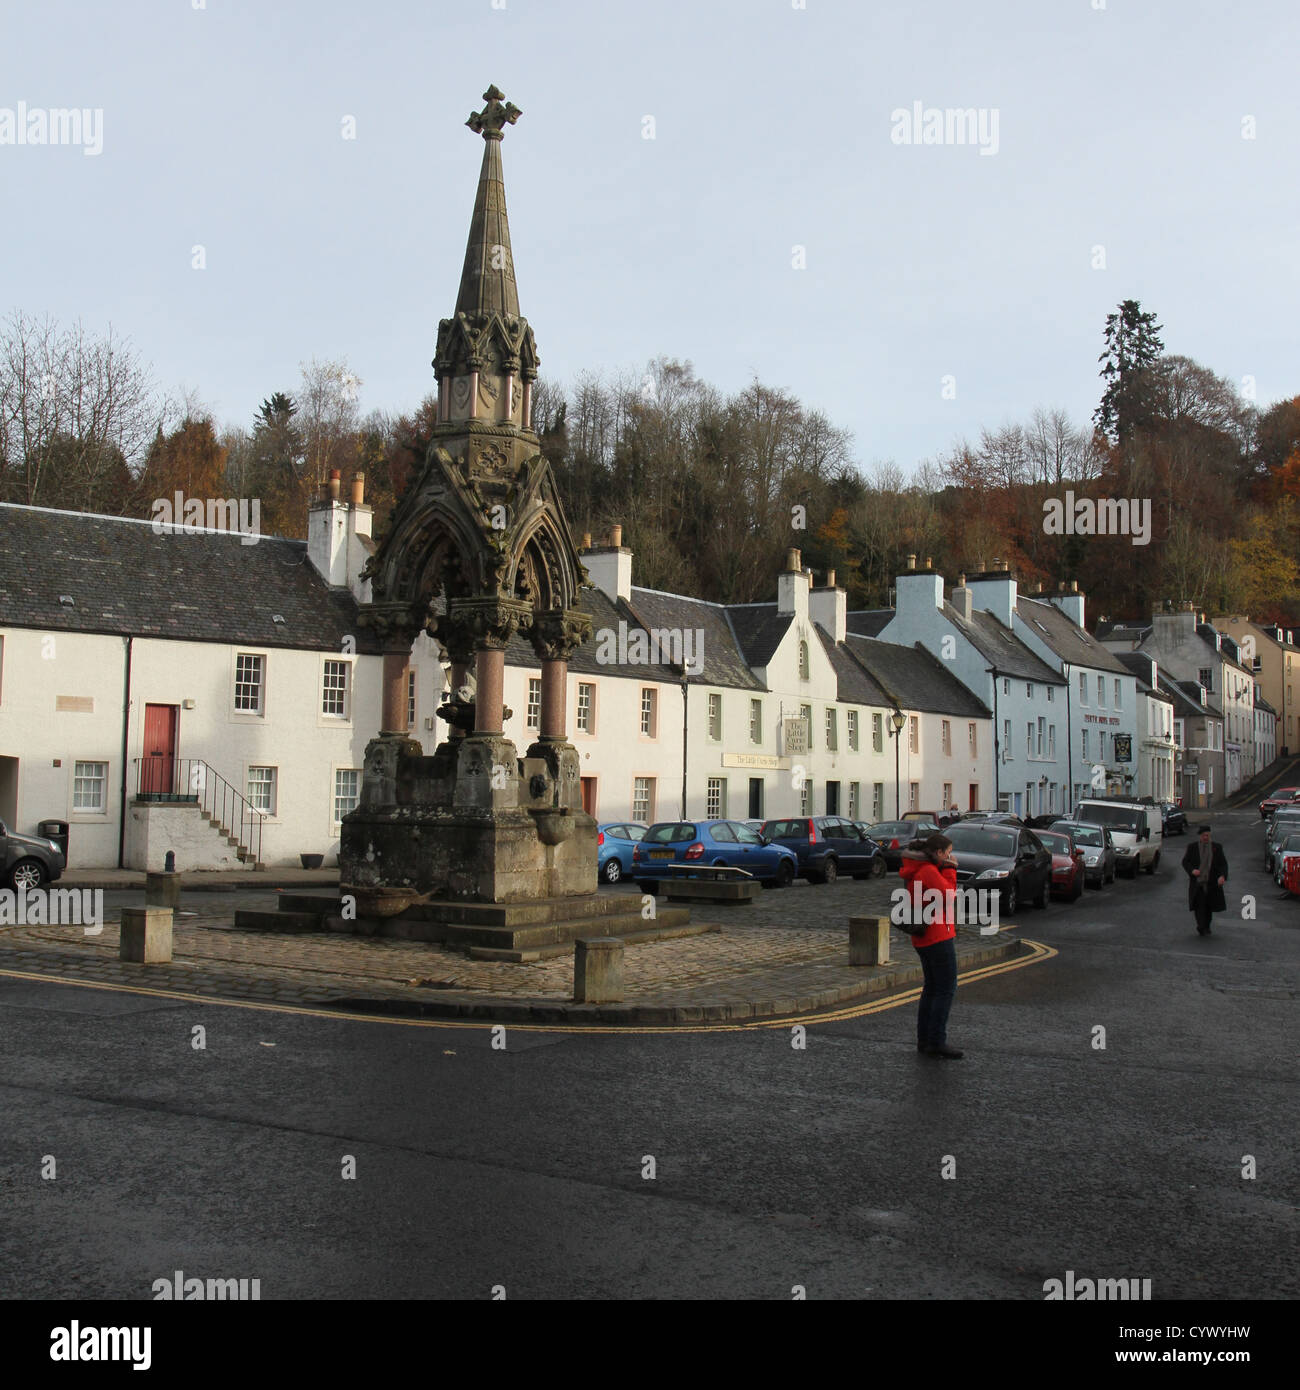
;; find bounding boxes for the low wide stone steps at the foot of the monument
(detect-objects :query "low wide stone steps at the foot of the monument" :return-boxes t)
[235,892,706,963]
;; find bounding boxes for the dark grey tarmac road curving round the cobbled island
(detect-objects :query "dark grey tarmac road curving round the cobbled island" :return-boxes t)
[0,810,1300,1300]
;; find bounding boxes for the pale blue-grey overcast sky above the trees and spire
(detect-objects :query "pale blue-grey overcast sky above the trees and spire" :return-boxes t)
[0,0,1300,470]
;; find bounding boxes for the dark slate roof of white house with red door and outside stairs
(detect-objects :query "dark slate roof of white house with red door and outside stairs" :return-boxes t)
[0,505,380,653]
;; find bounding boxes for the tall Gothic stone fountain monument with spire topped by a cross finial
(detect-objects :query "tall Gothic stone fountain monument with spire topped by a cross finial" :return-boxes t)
[339,86,681,958]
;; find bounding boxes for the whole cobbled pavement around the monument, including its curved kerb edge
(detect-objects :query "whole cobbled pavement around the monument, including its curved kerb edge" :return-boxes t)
[0,870,1034,1027]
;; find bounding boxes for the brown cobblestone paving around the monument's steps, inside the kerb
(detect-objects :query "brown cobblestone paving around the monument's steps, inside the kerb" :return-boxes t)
[0,877,1023,1005]
